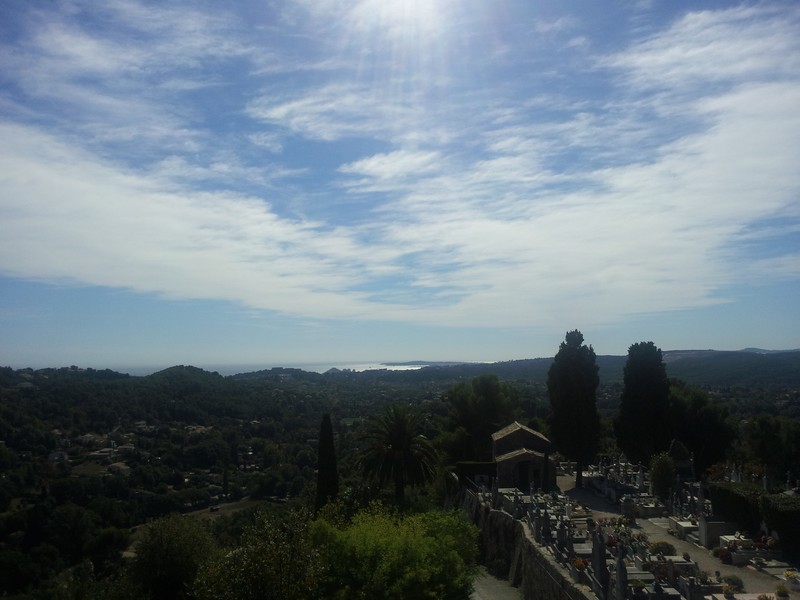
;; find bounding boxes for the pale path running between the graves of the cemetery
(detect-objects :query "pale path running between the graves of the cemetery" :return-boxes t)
[558,477,800,600]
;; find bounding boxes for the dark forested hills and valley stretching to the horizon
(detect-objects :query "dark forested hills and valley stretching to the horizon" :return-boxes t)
[0,353,800,599]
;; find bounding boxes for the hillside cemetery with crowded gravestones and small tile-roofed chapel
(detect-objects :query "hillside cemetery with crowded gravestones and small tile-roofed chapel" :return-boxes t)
[462,424,800,600]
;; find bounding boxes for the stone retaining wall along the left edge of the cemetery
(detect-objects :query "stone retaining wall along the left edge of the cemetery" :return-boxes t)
[461,490,597,600]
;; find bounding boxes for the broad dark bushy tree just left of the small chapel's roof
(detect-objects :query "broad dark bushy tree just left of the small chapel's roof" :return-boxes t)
[447,375,519,461]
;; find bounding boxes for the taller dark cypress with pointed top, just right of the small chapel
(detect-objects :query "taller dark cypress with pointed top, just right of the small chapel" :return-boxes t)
[547,329,600,487]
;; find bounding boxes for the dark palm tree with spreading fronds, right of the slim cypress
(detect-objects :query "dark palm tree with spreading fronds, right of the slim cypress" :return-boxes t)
[359,404,437,505]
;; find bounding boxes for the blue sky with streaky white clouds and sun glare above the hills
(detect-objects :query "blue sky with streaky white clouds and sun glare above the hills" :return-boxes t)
[0,0,800,369]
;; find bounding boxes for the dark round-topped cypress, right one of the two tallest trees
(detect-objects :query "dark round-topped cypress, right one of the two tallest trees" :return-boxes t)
[614,342,672,464]
